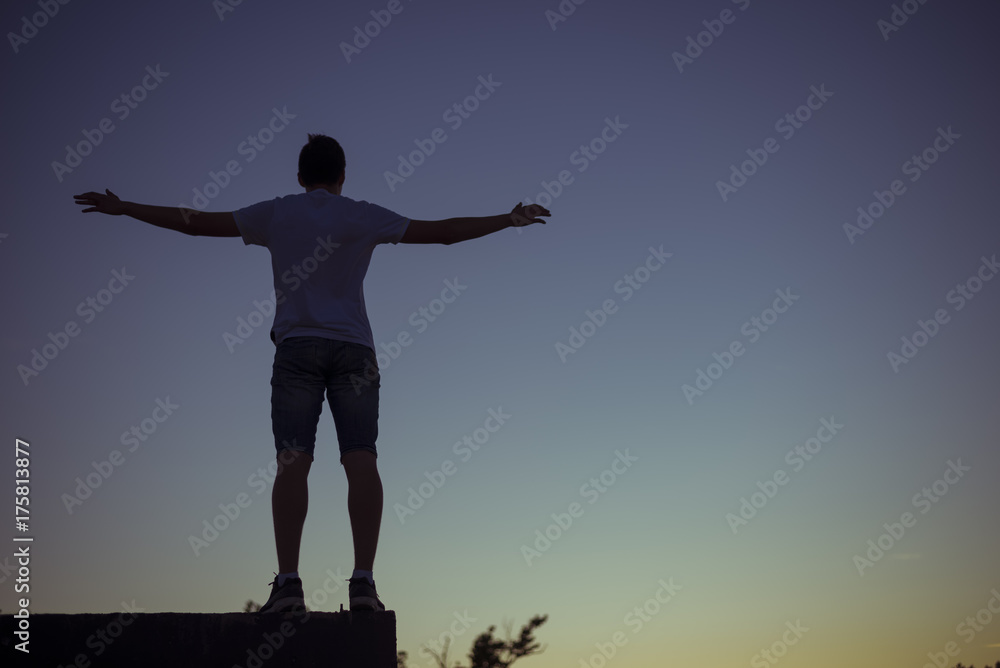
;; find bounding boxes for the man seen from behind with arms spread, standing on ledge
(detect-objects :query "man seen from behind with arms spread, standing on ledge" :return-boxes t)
[75,134,551,613]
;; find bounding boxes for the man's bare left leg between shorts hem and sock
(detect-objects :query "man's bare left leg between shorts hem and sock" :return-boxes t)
[271,450,313,573]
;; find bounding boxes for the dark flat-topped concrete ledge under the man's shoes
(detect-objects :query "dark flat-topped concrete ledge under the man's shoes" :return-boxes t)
[0,611,396,668]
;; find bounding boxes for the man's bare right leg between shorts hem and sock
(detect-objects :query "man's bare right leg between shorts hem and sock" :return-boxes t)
[341,450,382,571]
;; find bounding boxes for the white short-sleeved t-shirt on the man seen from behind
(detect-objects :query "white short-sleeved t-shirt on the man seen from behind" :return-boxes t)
[233,189,410,350]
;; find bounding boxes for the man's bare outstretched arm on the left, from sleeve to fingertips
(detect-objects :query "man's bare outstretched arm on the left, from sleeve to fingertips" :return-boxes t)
[74,190,241,237]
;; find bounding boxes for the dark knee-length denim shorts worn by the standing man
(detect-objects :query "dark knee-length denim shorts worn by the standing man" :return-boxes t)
[271,336,380,464]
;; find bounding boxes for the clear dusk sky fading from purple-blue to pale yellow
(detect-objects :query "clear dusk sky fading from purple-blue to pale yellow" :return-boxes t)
[0,0,1000,668]
